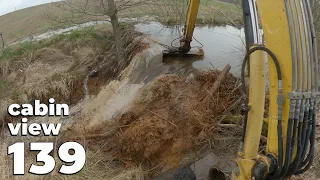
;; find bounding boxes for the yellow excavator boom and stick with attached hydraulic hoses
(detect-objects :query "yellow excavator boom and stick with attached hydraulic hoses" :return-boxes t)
[164,0,319,180]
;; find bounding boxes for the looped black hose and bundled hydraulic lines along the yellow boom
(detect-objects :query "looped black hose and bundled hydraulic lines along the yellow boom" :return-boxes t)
[241,0,319,179]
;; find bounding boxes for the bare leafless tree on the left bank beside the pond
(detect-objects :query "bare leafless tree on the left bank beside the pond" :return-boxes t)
[42,0,150,61]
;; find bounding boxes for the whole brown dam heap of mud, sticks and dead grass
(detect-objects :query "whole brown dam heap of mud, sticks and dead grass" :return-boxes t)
[62,67,241,178]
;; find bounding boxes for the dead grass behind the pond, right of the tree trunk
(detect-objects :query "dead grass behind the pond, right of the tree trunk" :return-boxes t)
[121,0,242,26]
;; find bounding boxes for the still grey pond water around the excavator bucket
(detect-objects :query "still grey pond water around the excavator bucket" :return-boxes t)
[136,22,245,76]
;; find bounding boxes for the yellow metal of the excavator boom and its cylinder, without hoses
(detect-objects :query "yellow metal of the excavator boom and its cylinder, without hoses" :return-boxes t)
[233,0,292,180]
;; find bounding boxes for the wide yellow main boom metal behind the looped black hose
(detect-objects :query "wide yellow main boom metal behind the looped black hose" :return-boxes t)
[257,0,292,158]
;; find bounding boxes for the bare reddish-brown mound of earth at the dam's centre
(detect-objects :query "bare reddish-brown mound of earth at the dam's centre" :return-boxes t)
[119,71,240,165]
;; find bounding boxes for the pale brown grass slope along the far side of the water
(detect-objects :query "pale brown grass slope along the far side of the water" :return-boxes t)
[0,0,242,45]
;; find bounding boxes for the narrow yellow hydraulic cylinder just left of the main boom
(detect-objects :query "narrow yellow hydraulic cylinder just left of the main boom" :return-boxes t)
[234,46,266,180]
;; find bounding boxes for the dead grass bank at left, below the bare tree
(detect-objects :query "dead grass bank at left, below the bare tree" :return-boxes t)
[0,23,143,125]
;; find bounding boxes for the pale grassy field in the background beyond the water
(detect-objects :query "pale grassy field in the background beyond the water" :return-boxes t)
[0,0,241,45]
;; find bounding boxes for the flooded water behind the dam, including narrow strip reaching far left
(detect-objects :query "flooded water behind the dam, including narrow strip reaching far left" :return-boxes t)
[14,20,245,84]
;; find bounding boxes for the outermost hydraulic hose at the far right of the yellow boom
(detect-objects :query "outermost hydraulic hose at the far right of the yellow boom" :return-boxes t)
[290,0,318,175]
